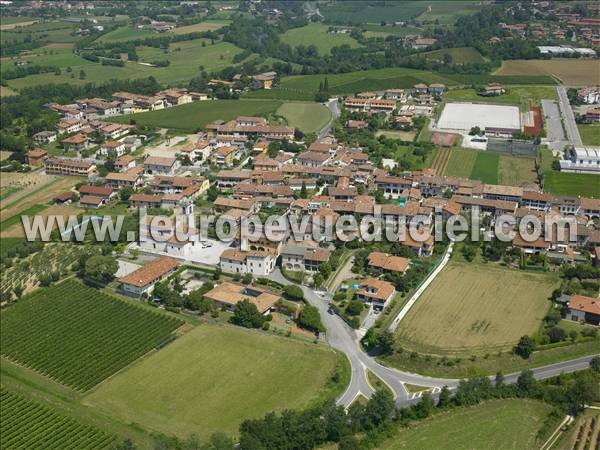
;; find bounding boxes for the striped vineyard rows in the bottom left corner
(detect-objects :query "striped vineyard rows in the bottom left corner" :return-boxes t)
[0,388,115,450]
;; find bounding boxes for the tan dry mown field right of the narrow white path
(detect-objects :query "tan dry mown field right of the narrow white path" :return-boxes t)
[396,261,558,356]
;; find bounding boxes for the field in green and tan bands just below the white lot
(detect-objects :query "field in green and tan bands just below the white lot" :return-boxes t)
[443,148,537,186]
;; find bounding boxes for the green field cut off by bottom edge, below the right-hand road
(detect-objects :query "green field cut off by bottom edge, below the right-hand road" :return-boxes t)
[379,399,552,450]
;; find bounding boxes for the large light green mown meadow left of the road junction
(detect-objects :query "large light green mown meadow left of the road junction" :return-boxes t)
[83,325,338,439]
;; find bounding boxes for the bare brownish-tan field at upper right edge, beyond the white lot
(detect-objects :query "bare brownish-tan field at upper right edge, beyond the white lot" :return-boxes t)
[495,59,600,86]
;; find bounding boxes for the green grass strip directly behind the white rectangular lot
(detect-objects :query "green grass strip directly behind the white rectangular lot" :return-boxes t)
[440,85,557,111]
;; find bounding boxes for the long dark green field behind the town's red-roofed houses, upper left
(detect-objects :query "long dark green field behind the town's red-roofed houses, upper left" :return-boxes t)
[111,100,282,132]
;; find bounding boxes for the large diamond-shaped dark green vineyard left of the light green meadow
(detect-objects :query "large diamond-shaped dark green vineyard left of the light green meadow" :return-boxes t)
[0,280,182,391]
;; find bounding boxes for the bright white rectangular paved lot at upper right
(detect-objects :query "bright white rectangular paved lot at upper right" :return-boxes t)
[437,103,521,132]
